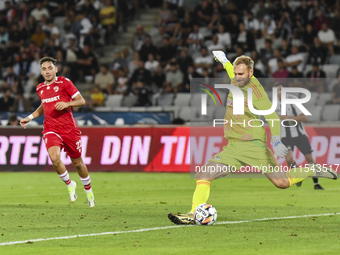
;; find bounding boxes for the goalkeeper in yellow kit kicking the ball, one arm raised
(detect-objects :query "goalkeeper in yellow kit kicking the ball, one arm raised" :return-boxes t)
[168,51,338,224]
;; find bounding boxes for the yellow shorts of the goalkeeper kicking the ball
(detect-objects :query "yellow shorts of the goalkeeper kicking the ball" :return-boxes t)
[209,140,279,173]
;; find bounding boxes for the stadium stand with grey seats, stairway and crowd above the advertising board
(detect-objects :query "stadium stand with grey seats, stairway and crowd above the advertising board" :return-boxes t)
[0,0,340,122]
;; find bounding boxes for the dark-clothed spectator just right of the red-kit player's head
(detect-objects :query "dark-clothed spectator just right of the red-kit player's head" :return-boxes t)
[77,45,98,81]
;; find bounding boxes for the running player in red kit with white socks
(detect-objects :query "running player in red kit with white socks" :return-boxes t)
[20,57,95,207]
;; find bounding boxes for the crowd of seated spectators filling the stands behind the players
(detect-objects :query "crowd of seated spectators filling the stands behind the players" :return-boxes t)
[0,0,340,111]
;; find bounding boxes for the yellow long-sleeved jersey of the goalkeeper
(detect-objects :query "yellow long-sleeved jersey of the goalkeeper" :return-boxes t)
[224,62,280,143]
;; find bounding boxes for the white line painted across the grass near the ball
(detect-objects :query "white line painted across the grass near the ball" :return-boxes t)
[0,212,340,246]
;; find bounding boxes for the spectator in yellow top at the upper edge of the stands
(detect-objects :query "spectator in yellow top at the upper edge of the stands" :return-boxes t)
[99,0,117,44]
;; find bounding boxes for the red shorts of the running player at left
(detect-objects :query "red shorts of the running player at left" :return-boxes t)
[43,130,81,158]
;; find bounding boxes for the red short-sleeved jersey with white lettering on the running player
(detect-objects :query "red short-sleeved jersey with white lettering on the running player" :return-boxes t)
[37,77,79,134]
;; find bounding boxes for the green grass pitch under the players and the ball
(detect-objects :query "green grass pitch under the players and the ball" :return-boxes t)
[0,172,340,255]
